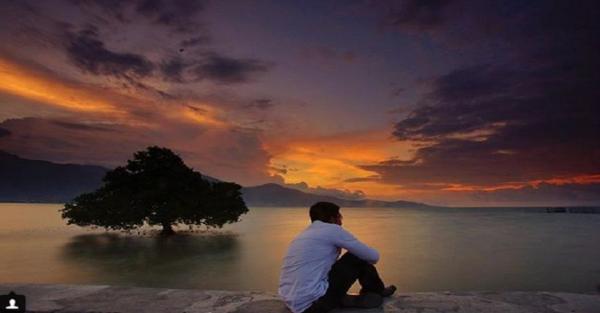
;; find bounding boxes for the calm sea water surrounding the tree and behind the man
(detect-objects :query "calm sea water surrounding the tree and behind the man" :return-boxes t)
[0,204,600,292]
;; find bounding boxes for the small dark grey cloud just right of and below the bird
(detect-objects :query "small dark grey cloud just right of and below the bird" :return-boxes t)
[192,53,269,84]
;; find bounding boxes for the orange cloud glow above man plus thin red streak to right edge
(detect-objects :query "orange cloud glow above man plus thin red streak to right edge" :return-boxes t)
[266,126,600,199]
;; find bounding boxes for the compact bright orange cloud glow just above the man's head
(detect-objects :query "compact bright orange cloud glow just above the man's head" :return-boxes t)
[266,129,412,198]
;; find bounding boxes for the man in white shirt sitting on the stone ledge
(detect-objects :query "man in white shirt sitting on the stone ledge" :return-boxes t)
[279,202,396,313]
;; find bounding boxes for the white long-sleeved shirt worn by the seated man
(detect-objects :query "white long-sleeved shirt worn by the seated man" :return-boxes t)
[279,221,379,313]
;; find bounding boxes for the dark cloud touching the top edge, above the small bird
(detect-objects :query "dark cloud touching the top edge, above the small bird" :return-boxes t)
[136,0,204,32]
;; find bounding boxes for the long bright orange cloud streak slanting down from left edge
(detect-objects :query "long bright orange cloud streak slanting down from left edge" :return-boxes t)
[0,57,234,128]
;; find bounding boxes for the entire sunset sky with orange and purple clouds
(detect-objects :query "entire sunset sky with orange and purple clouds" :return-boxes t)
[0,0,600,206]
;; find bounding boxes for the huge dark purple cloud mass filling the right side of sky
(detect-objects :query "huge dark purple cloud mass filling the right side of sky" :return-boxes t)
[364,1,600,184]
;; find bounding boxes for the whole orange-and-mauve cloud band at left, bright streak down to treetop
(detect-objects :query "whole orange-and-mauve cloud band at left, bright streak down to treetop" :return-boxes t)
[0,56,272,185]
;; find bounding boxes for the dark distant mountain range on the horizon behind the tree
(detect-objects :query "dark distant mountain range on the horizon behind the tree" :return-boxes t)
[0,151,429,208]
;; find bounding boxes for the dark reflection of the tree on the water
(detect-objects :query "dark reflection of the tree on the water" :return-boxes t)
[62,233,240,288]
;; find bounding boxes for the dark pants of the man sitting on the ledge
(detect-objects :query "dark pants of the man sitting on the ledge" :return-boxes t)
[303,252,385,313]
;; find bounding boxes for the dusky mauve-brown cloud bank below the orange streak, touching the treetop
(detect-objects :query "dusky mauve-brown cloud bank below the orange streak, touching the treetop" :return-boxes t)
[0,118,277,185]
